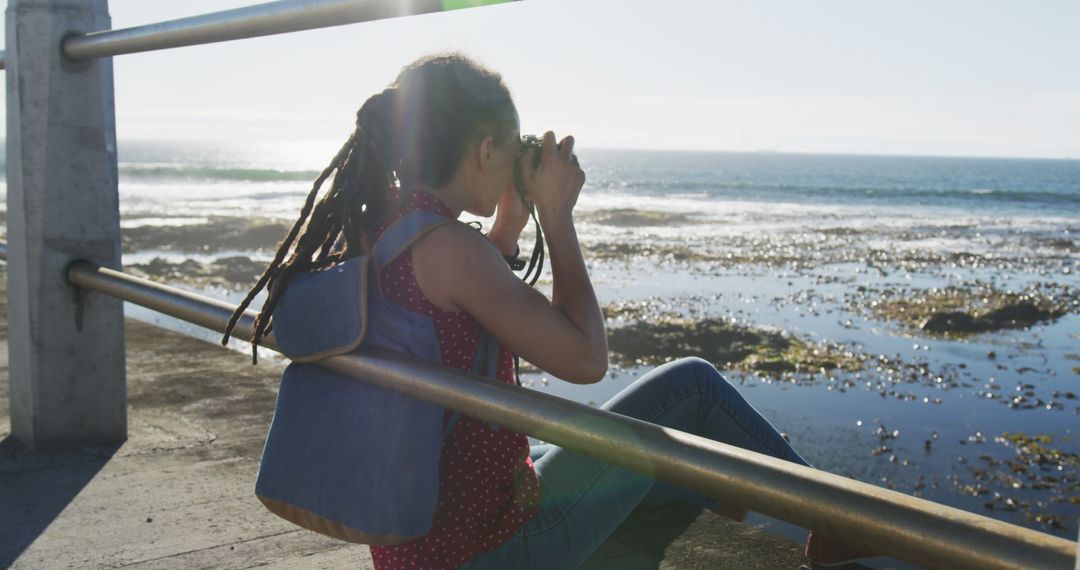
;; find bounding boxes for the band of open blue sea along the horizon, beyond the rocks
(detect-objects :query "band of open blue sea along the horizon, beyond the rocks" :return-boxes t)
[109,143,1080,215]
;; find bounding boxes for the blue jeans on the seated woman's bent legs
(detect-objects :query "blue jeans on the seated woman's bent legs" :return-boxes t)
[462,358,808,569]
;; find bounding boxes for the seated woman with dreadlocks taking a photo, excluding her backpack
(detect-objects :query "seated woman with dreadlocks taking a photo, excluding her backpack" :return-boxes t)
[223,54,872,568]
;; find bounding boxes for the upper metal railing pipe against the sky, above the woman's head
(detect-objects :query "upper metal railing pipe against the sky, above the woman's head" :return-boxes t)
[63,0,514,59]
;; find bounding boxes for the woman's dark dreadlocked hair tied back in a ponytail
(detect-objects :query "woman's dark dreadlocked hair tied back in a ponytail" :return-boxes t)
[221,53,517,363]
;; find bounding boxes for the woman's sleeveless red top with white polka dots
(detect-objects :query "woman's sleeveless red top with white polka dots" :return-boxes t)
[370,192,540,570]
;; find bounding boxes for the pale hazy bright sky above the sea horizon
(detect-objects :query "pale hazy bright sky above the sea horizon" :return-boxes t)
[2,0,1080,162]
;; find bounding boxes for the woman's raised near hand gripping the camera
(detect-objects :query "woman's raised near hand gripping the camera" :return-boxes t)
[524,131,585,226]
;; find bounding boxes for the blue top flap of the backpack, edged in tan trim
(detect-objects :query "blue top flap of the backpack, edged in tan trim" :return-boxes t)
[273,256,372,362]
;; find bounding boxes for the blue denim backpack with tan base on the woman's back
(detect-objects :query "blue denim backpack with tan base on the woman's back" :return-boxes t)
[255,211,499,545]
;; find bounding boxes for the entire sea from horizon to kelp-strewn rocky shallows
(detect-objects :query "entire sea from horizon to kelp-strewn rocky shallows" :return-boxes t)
[2,141,1080,552]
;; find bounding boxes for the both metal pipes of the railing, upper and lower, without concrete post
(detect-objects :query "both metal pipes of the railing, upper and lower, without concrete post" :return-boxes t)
[0,0,1077,569]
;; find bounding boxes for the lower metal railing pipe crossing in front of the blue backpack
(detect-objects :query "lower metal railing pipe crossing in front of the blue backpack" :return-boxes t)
[0,249,1077,569]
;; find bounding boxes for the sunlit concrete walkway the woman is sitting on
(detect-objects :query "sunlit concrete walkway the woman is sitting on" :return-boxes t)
[0,270,805,570]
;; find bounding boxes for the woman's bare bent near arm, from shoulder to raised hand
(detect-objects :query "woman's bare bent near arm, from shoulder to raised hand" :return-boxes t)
[413,133,608,383]
